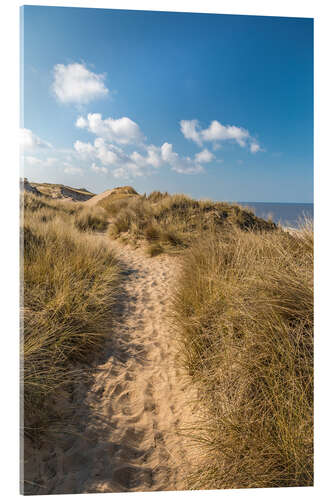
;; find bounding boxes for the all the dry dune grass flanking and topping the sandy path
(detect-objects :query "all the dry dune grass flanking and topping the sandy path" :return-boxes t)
[22,186,313,489]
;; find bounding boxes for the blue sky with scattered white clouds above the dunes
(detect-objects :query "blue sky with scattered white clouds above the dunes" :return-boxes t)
[21,6,313,203]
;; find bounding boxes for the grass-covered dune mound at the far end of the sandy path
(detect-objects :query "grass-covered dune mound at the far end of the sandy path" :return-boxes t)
[100,191,276,255]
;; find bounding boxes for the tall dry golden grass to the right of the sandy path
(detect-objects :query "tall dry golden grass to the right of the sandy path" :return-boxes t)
[174,223,313,489]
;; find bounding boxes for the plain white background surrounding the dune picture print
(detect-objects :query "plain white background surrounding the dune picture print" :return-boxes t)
[0,0,333,500]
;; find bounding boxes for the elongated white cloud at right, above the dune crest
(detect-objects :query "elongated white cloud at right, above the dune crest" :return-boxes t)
[180,120,261,153]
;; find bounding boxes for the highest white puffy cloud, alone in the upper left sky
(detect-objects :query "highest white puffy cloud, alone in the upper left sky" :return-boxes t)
[52,63,109,104]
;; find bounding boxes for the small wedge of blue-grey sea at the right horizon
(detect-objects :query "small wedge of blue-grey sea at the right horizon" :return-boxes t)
[238,201,313,228]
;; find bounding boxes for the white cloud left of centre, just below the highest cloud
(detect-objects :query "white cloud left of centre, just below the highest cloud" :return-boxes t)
[76,113,144,144]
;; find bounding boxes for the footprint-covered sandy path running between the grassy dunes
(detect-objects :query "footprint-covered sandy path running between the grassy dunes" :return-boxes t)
[24,242,197,493]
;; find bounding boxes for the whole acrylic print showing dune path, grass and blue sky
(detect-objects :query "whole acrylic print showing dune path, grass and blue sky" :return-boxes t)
[21,6,313,495]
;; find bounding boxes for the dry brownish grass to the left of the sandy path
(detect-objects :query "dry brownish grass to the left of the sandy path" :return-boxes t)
[22,194,119,437]
